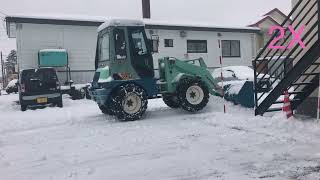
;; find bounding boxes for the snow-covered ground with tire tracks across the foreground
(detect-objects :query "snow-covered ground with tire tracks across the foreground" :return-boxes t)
[0,95,320,180]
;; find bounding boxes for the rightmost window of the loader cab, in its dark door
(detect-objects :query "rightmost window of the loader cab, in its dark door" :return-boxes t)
[131,30,148,55]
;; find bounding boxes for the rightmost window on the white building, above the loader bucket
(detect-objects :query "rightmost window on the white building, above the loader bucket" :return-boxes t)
[221,40,241,57]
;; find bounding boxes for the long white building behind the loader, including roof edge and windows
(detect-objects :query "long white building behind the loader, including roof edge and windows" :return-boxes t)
[6,16,260,83]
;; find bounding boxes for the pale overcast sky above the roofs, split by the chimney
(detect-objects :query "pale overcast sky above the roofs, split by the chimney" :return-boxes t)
[0,0,291,53]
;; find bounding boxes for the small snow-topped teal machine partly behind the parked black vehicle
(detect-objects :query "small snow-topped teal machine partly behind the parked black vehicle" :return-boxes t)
[38,49,90,100]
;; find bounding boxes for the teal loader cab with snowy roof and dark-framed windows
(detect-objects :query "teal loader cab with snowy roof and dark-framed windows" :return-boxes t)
[95,20,156,80]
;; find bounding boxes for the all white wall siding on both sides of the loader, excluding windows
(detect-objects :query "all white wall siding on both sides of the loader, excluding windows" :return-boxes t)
[17,23,257,83]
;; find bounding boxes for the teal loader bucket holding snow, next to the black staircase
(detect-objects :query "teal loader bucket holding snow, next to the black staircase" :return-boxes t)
[224,81,254,108]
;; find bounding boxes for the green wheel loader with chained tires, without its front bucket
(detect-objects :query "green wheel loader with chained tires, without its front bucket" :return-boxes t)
[89,19,219,121]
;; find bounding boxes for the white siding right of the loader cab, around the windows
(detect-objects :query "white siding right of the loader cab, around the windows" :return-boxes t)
[147,30,257,68]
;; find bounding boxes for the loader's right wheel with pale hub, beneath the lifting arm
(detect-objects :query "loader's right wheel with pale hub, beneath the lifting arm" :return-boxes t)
[177,79,209,112]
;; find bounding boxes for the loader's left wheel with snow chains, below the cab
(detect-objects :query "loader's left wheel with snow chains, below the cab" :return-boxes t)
[112,84,148,121]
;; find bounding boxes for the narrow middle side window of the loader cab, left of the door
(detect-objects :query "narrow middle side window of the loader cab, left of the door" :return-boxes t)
[114,29,127,60]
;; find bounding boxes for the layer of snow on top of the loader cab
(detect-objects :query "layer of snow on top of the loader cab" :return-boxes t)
[98,19,144,32]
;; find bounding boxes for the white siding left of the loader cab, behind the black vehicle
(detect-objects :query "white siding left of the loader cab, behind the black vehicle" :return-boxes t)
[17,24,97,83]
